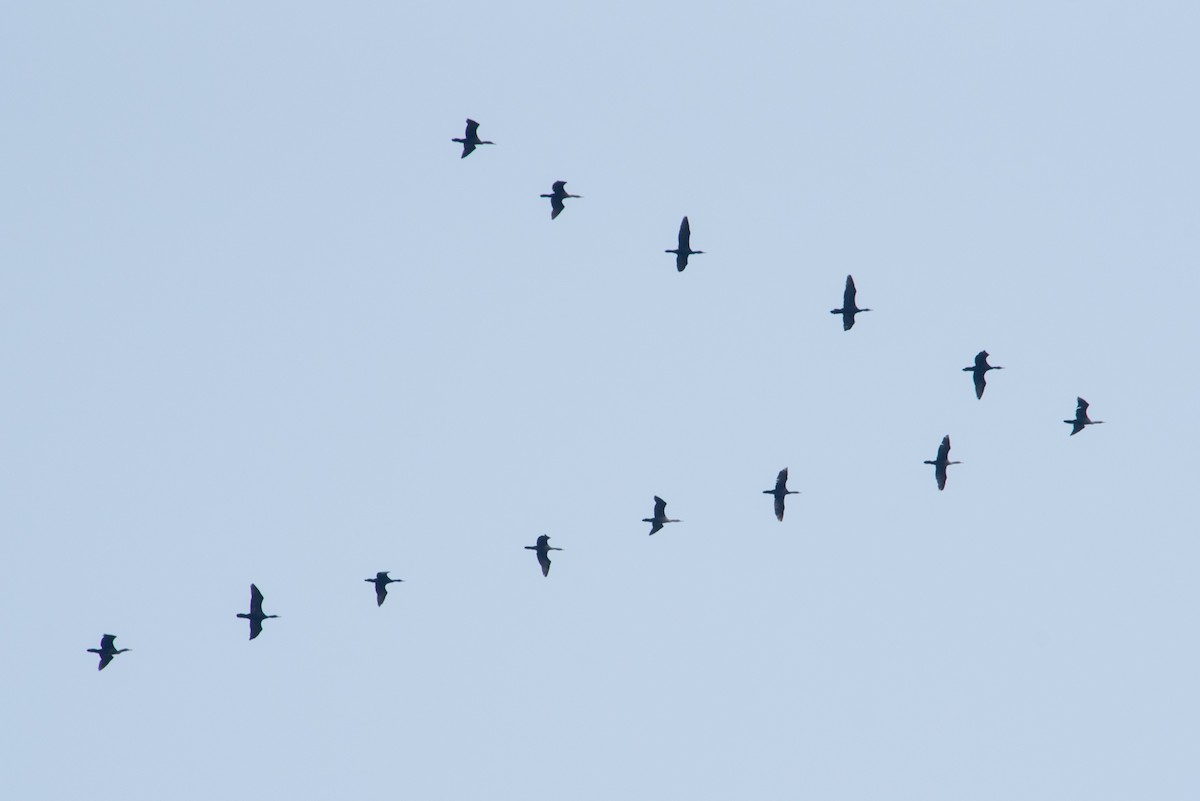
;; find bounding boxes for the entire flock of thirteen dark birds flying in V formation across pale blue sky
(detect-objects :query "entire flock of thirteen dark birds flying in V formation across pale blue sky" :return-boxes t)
[88,119,1104,670]
